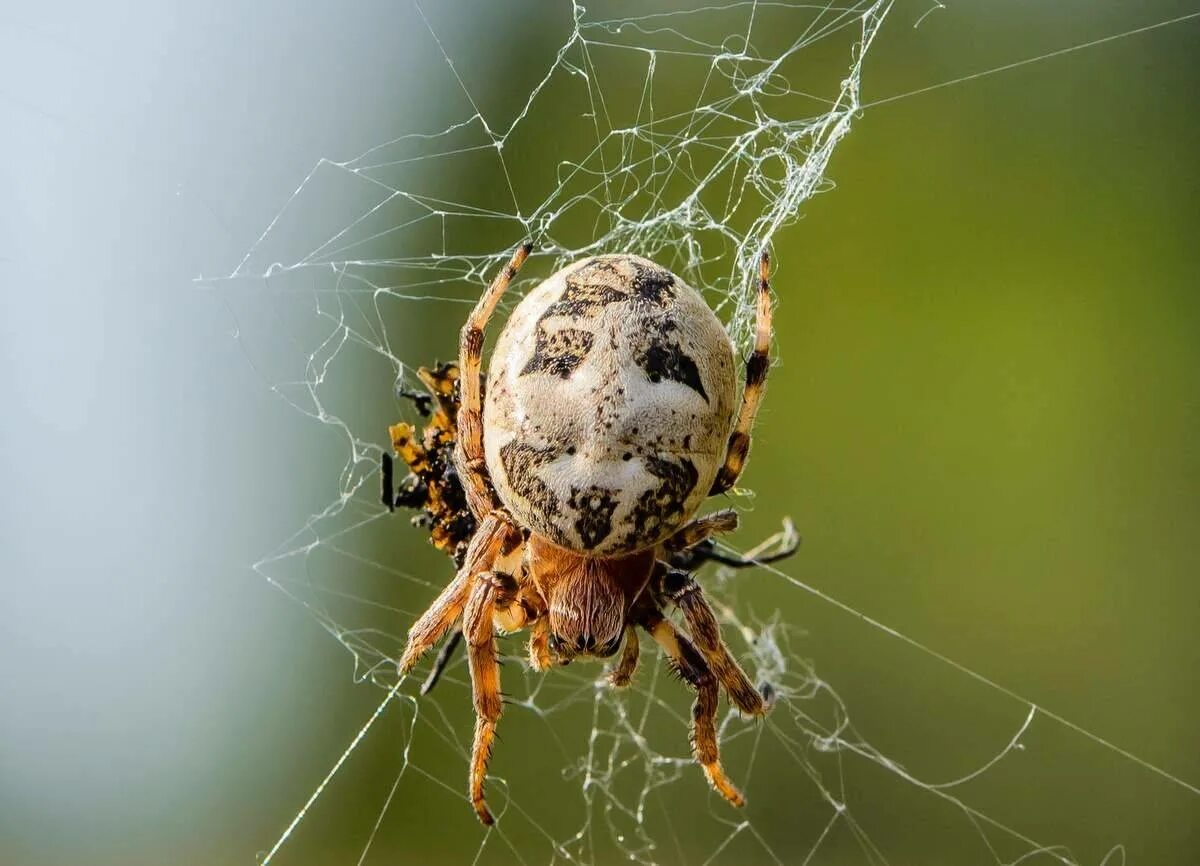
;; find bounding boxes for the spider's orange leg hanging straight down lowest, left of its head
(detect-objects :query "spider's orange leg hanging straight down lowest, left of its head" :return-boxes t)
[462,572,517,825]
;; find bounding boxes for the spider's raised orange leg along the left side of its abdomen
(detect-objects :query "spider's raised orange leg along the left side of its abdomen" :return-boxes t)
[458,243,533,516]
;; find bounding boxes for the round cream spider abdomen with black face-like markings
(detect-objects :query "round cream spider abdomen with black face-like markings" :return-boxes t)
[484,255,736,555]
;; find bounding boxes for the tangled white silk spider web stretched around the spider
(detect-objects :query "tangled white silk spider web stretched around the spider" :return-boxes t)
[201,0,1200,864]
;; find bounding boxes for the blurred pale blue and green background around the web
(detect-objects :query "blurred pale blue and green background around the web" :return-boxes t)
[0,0,1200,866]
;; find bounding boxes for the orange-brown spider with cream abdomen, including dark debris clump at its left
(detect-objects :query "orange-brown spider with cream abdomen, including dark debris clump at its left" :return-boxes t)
[382,243,794,825]
